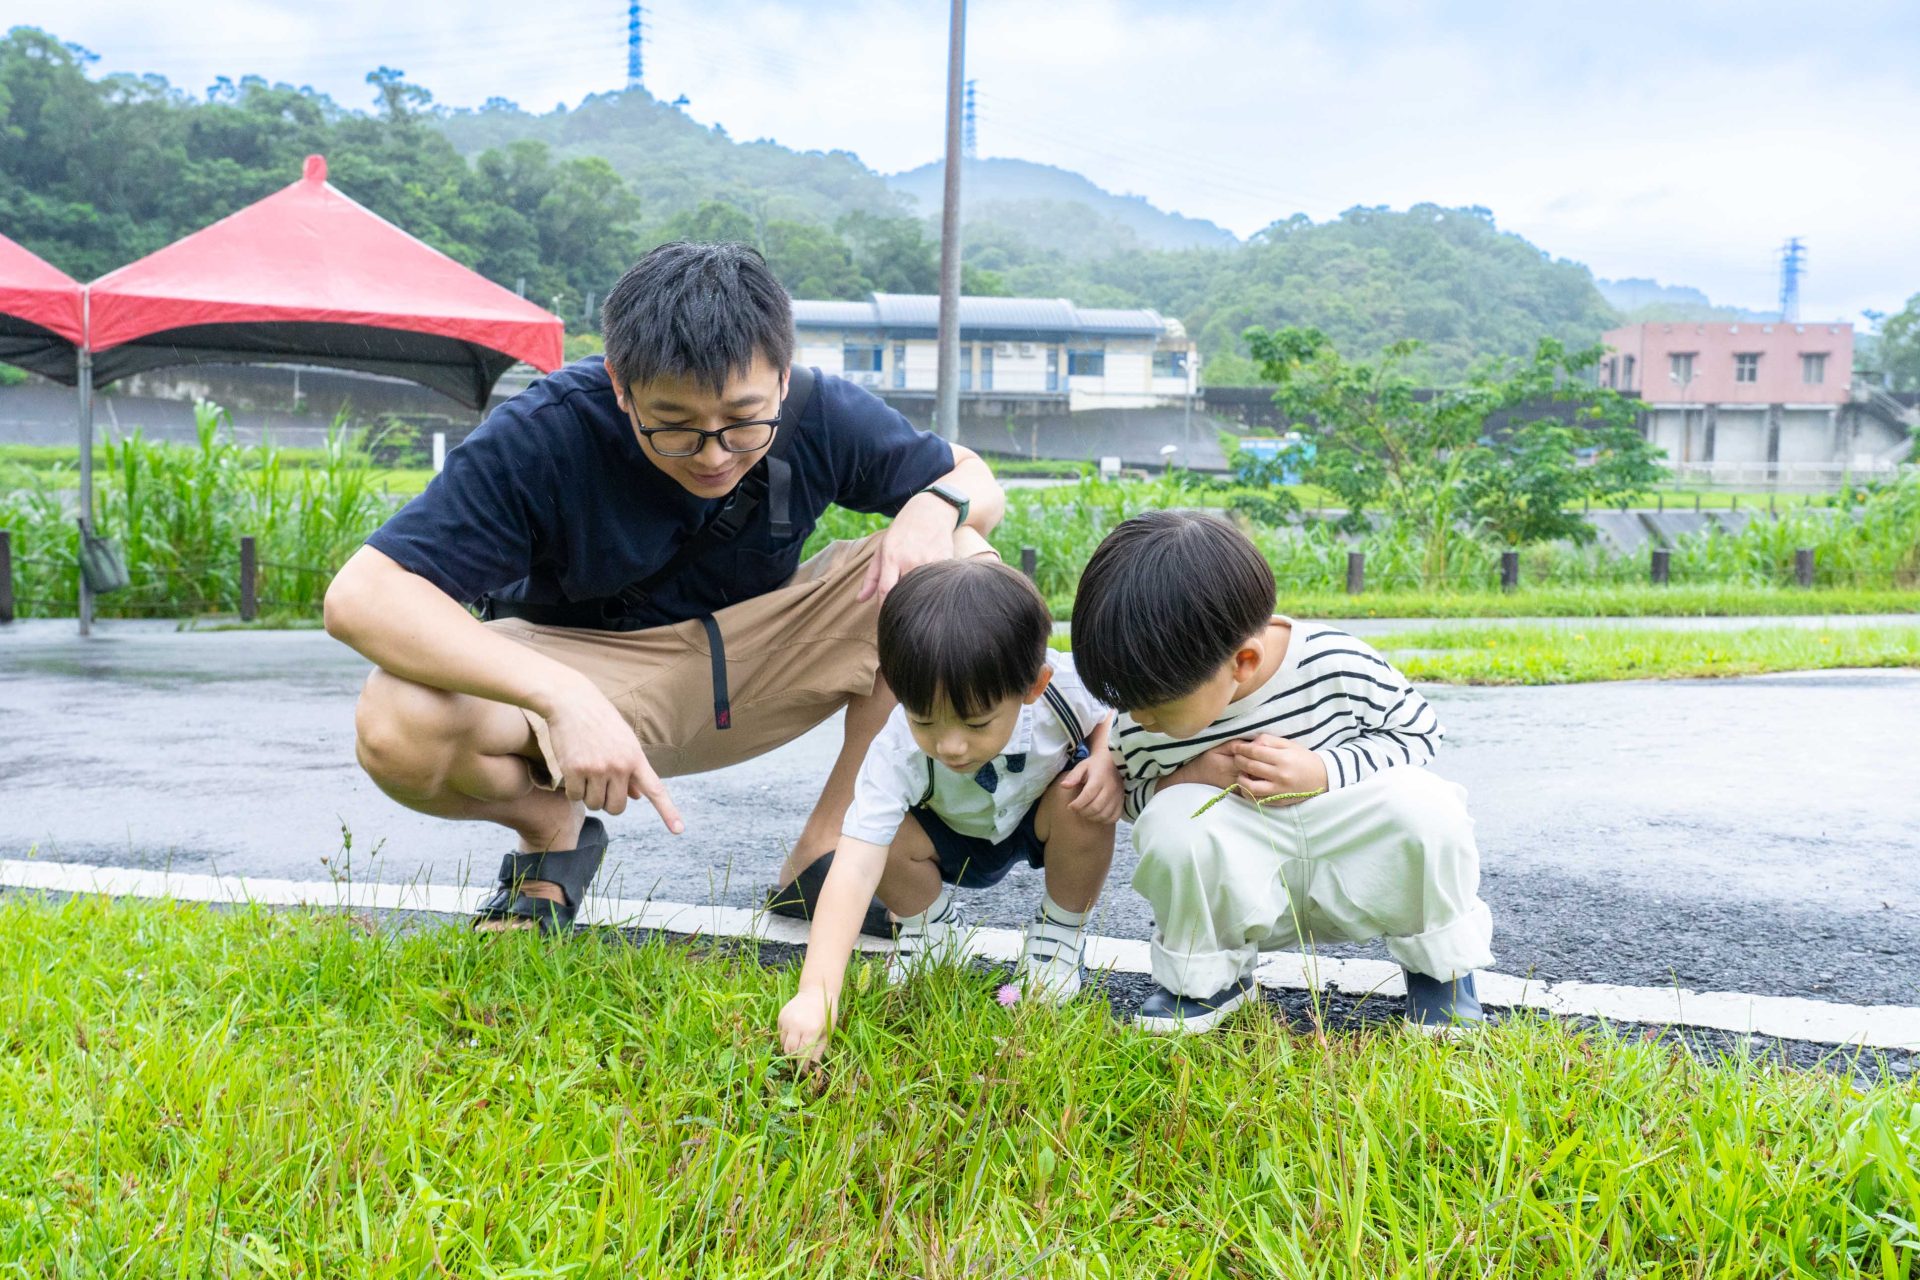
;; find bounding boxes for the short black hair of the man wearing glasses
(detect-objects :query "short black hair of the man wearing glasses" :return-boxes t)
[601,240,793,393]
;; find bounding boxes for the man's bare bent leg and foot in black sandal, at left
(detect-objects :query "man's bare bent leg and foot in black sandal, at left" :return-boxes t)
[353,670,586,931]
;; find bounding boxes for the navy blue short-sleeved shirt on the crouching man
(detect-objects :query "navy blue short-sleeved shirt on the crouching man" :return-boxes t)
[367,355,954,626]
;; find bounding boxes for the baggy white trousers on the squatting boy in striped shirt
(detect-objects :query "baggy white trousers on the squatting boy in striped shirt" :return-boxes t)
[1133,768,1494,996]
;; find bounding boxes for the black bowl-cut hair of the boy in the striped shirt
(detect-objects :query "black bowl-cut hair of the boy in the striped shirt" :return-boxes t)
[1073,510,1273,710]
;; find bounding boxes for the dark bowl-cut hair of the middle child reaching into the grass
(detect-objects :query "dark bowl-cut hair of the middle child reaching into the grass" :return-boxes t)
[879,560,1054,720]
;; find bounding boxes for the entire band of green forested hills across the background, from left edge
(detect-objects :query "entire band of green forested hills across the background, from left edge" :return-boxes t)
[11,27,1617,382]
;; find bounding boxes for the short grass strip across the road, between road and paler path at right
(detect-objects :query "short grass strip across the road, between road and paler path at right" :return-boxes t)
[1369,624,1920,685]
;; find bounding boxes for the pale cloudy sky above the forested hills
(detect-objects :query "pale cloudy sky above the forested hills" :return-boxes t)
[26,0,1920,320]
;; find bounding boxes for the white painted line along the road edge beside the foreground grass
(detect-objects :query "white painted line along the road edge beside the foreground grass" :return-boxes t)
[0,858,1920,1050]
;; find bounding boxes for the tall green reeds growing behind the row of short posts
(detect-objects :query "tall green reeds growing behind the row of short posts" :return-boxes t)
[0,405,1920,616]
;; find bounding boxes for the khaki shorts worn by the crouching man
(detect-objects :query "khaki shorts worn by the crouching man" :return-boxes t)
[486,533,879,789]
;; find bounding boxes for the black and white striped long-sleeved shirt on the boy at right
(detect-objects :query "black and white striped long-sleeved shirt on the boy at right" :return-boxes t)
[1112,618,1442,821]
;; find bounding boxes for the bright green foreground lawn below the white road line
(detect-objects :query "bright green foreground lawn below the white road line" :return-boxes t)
[0,896,1920,1278]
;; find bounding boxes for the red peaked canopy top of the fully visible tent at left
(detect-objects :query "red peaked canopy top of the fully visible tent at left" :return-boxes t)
[88,155,563,409]
